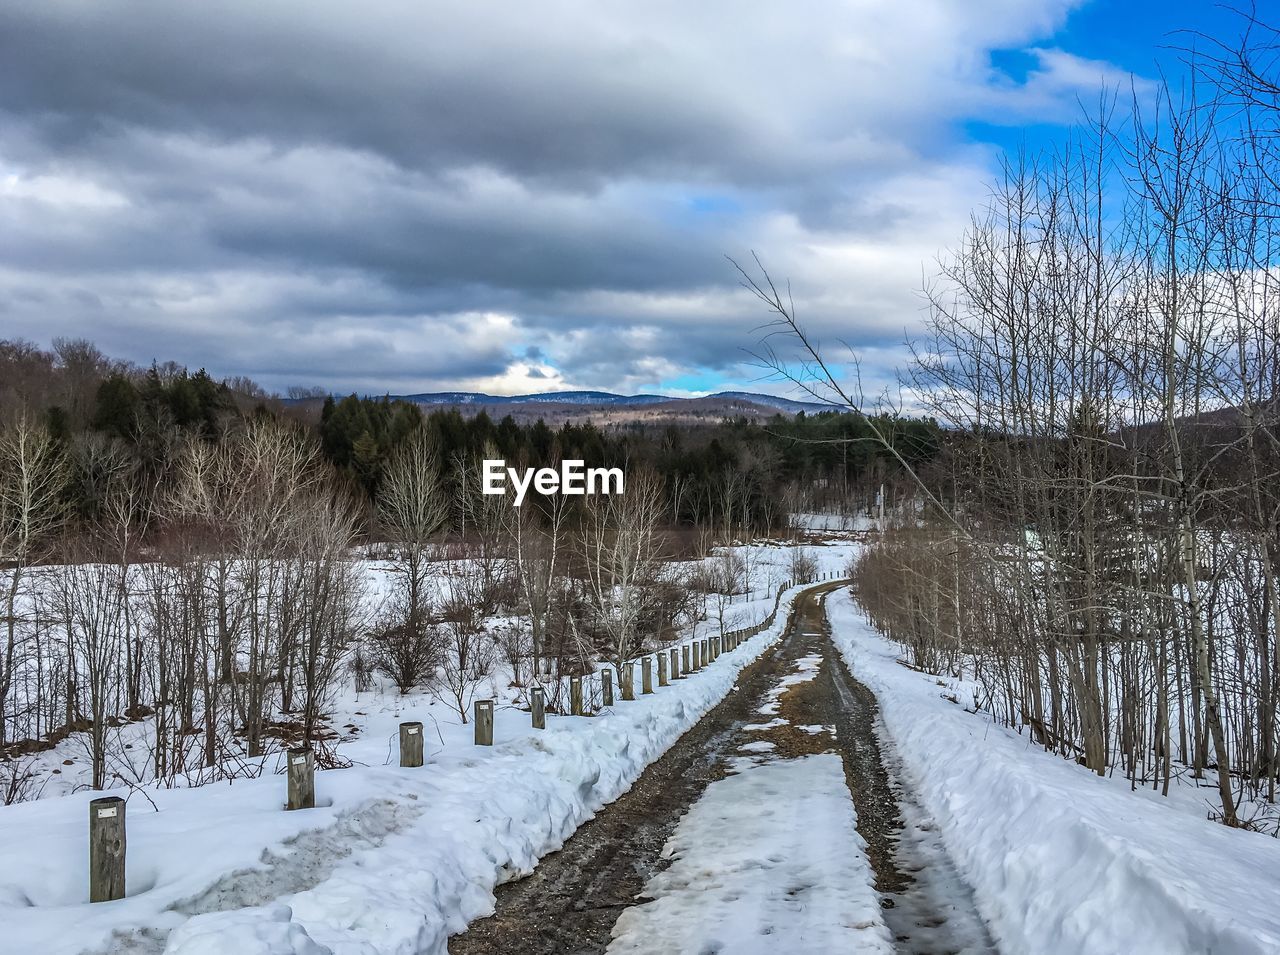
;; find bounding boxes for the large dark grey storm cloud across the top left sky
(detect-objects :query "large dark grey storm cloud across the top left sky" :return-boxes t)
[0,3,788,186]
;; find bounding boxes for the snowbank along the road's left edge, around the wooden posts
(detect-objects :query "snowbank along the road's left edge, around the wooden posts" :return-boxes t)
[0,589,814,955]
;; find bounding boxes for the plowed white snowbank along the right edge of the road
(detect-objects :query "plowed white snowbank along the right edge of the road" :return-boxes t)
[827,593,1280,955]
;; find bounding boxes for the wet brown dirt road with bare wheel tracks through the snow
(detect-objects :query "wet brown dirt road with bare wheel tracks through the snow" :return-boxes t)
[449,584,996,955]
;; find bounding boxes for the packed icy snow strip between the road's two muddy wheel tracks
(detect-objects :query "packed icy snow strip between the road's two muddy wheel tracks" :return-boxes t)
[608,681,895,955]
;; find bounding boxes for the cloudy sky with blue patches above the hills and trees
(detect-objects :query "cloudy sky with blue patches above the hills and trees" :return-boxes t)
[0,0,1239,396]
